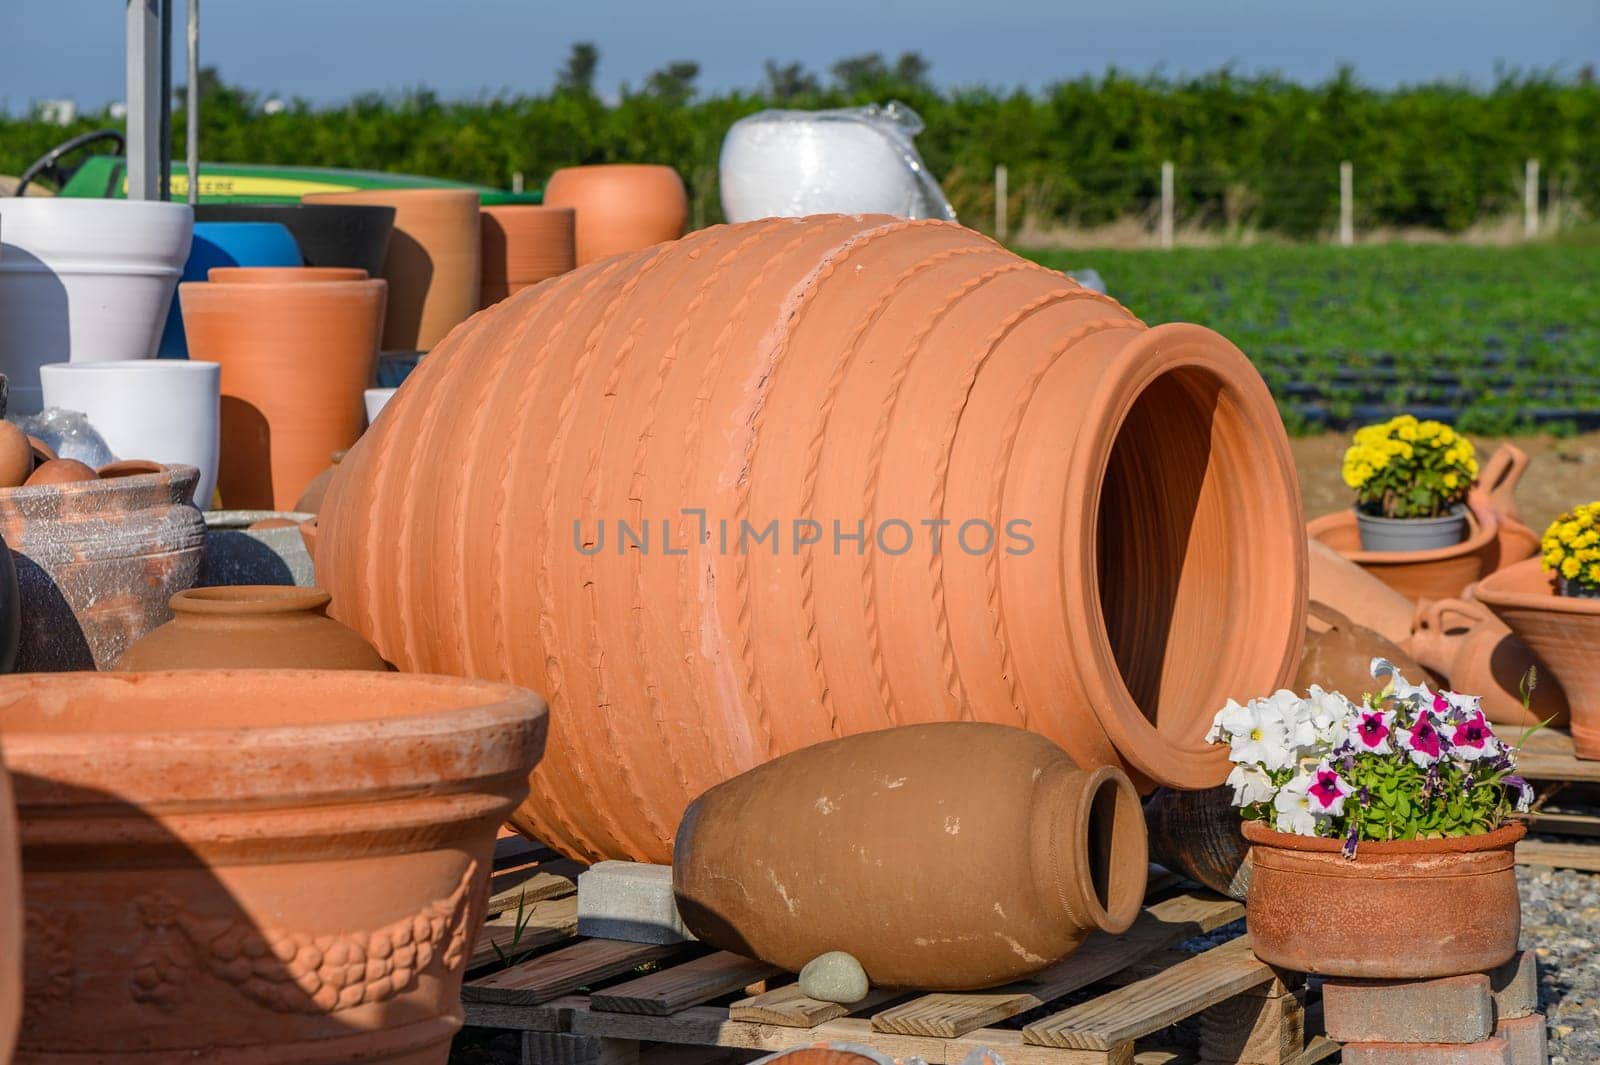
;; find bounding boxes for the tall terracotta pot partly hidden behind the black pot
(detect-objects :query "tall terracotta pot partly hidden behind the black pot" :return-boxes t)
[304,189,482,352]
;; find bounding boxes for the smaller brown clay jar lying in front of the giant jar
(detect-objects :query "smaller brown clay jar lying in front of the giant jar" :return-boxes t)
[672,721,1147,990]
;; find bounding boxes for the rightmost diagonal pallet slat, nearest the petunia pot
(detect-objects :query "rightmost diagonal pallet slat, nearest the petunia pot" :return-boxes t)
[1022,935,1277,1051]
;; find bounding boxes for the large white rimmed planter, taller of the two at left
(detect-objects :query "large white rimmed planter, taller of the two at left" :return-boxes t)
[0,197,194,414]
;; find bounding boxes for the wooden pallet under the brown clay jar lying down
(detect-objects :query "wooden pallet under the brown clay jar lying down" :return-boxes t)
[462,844,1338,1065]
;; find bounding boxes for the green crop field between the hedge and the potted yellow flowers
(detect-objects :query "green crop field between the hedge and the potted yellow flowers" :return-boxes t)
[1027,241,1600,433]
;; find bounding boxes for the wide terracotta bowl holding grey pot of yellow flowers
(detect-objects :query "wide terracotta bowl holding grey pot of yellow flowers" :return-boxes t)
[1306,493,1499,601]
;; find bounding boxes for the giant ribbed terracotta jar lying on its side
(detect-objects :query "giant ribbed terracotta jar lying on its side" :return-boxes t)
[317,216,1306,862]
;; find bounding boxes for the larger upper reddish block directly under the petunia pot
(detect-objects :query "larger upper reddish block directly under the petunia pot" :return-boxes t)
[1322,972,1494,1043]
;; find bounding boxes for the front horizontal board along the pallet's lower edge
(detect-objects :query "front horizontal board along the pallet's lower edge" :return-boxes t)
[573,1006,1133,1065]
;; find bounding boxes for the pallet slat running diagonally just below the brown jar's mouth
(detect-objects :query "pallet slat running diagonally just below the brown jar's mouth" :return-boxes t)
[872,892,1245,1049]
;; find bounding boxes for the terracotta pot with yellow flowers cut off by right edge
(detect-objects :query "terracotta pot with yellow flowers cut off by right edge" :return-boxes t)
[1474,558,1600,758]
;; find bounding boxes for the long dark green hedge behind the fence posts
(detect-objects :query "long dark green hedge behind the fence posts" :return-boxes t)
[0,61,1600,237]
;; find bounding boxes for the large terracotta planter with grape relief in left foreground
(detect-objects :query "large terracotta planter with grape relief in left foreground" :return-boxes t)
[0,670,544,1065]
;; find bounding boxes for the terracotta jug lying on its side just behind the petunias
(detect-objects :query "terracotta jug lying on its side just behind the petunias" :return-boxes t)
[1402,592,1568,725]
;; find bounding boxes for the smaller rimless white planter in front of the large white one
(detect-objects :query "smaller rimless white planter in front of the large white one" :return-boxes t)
[38,358,222,510]
